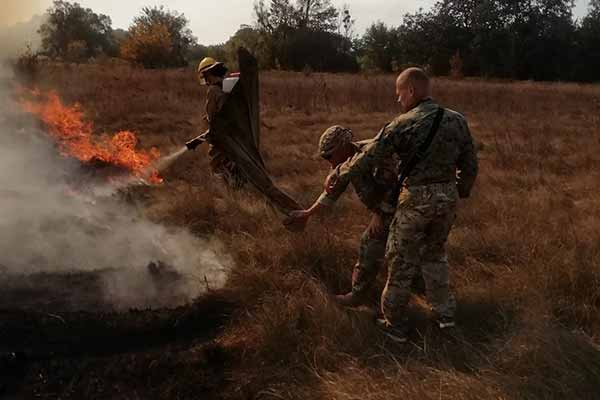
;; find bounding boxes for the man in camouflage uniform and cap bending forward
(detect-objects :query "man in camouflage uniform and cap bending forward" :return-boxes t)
[288,125,408,307]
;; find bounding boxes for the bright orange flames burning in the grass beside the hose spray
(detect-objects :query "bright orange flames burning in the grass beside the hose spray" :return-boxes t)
[21,90,162,184]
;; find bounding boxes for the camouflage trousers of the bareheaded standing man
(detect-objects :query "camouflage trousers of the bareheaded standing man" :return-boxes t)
[381,183,458,325]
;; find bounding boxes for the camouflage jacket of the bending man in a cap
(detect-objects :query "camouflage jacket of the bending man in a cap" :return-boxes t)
[318,139,398,212]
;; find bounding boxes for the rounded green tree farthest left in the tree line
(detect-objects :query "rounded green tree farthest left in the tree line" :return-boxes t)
[38,0,116,59]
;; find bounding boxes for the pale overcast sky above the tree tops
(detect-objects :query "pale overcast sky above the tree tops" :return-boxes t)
[0,0,589,44]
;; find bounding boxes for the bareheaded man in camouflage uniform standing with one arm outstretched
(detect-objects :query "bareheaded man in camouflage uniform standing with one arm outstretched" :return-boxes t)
[302,68,478,342]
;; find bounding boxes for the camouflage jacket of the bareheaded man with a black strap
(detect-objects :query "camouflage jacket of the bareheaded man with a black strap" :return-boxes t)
[324,99,477,212]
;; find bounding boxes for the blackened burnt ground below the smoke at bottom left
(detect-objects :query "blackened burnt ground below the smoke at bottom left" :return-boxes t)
[0,282,238,399]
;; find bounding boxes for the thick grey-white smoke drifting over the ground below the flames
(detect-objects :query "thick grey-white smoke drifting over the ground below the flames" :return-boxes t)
[0,65,231,309]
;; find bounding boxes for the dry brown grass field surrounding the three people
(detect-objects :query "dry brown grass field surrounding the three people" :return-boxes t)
[4,66,600,400]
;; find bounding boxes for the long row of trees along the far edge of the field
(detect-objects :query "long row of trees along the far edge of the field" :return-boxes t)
[34,0,600,81]
